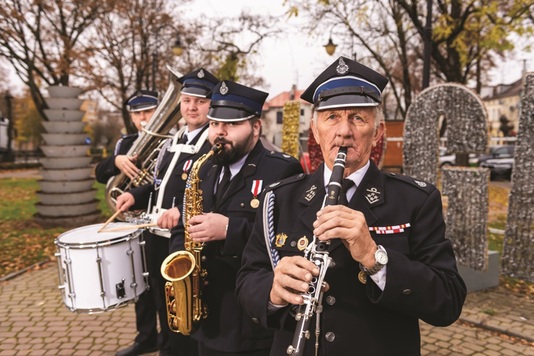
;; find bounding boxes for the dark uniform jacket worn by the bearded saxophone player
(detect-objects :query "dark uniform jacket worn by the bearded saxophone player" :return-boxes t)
[173,141,302,354]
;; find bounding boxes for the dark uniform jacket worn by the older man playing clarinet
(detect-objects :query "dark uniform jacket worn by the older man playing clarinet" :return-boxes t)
[237,163,466,356]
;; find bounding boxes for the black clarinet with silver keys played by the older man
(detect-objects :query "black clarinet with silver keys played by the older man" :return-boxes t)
[287,147,347,356]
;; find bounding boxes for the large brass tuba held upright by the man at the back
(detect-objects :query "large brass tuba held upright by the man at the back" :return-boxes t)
[106,66,182,211]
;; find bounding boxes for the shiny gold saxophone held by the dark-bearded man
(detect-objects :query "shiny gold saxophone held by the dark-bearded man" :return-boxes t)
[161,144,222,335]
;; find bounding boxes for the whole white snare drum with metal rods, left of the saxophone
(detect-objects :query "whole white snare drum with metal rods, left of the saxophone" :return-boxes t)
[55,223,148,314]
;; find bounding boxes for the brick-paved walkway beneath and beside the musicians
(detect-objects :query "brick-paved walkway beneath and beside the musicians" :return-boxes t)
[0,263,534,356]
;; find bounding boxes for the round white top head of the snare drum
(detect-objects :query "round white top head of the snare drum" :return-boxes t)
[57,222,138,245]
